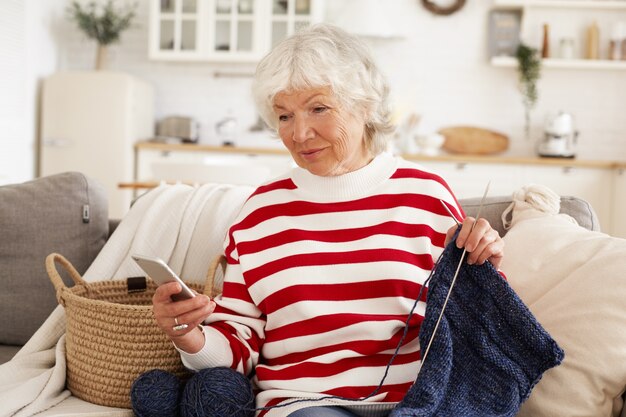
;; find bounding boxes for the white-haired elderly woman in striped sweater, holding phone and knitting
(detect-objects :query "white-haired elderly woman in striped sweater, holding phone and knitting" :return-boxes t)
[143,25,503,417]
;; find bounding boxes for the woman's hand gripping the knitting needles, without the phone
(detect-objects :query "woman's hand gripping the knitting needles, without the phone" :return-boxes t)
[446,217,504,269]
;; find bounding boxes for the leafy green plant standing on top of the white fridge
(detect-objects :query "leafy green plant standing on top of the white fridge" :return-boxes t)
[68,0,137,69]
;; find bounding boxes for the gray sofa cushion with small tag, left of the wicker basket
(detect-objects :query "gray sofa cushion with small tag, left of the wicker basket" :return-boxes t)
[0,172,109,345]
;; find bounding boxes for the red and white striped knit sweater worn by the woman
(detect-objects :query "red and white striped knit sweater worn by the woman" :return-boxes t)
[182,154,464,416]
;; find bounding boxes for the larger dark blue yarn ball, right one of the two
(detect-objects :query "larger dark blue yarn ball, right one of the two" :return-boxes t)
[180,367,254,417]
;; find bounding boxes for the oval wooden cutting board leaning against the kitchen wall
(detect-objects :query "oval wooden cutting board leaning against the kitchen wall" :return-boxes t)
[439,126,509,155]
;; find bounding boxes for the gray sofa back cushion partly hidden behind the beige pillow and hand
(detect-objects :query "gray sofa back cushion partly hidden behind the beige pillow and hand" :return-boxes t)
[459,196,600,236]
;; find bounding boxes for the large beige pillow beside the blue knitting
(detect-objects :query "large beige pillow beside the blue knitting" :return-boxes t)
[501,186,626,417]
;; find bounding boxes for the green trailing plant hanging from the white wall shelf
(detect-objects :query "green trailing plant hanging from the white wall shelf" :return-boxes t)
[515,43,541,139]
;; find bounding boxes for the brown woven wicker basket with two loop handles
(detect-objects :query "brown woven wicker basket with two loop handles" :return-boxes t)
[46,253,220,408]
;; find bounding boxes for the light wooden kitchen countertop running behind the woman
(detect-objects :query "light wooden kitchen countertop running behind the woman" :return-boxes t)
[135,142,626,169]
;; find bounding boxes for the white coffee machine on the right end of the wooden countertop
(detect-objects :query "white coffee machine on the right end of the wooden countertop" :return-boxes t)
[537,112,578,158]
